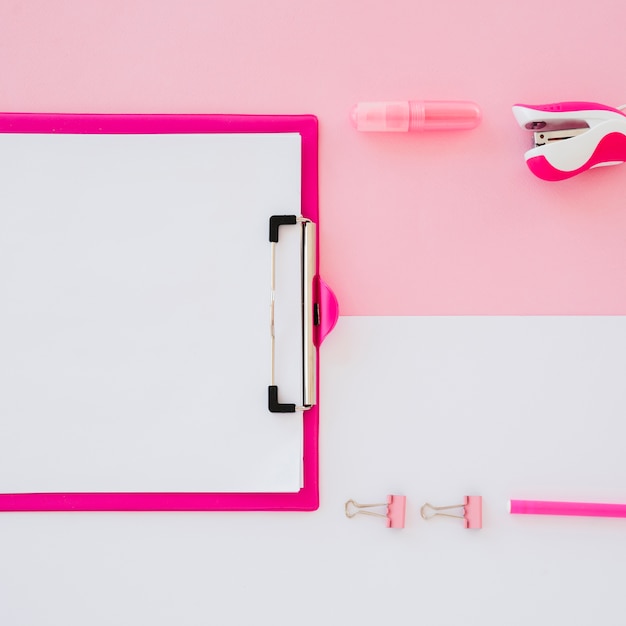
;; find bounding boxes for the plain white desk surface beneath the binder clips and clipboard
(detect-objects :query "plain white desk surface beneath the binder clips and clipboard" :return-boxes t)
[0,318,626,626]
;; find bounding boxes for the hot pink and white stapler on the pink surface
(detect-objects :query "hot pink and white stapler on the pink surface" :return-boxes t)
[513,102,626,180]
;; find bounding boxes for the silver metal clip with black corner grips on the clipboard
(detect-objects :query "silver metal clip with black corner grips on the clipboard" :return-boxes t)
[268,215,320,413]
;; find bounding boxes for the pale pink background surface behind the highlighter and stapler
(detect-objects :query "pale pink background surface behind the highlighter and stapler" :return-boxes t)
[0,0,626,315]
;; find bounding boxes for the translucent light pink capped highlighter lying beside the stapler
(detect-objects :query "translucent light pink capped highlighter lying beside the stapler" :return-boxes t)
[350,100,481,133]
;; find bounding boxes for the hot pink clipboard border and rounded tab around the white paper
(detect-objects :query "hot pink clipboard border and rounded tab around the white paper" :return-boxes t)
[0,113,338,511]
